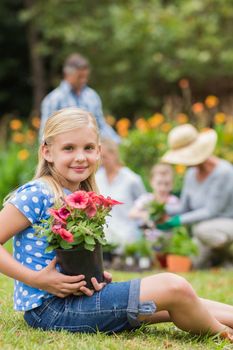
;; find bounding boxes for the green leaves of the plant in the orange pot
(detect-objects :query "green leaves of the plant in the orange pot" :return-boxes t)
[164,226,198,256]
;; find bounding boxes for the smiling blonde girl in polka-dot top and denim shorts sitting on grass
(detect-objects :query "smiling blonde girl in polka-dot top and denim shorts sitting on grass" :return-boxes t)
[0,108,233,338]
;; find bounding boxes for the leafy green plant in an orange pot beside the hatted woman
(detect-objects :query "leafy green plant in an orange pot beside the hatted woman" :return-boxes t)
[165,226,197,272]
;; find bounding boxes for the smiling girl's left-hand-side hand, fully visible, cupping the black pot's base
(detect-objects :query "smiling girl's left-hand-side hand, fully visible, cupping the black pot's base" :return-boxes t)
[33,258,88,298]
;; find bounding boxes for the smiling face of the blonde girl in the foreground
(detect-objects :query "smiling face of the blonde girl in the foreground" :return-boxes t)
[43,126,100,192]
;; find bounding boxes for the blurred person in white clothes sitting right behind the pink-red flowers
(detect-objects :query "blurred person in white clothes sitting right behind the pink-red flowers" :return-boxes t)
[96,139,146,254]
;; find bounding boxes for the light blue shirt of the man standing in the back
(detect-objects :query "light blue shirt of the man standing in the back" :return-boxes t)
[40,80,120,143]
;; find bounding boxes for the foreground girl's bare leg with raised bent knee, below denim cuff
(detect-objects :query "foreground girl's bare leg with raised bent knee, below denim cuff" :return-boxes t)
[140,273,233,334]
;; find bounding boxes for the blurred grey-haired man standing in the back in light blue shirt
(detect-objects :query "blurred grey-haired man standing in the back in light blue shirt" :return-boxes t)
[40,53,120,142]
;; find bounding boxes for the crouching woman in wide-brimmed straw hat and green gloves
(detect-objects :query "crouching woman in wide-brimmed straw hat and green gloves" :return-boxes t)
[159,124,233,268]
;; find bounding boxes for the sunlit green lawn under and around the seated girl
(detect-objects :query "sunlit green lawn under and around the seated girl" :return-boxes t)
[0,270,233,350]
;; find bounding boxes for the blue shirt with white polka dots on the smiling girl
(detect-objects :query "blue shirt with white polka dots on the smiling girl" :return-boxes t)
[9,179,55,311]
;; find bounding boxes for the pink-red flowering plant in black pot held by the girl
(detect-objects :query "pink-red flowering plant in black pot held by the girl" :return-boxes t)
[35,191,121,288]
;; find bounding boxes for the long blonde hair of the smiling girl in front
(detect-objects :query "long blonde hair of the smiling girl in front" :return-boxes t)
[33,107,99,202]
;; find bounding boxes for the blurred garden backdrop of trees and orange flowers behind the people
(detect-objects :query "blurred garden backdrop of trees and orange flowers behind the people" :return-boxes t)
[0,0,233,201]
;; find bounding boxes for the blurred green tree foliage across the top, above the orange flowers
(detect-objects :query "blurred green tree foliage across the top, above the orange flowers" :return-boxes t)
[0,0,233,116]
